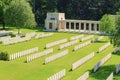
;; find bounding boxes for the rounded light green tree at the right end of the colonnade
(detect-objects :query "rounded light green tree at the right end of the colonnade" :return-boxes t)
[100,14,115,33]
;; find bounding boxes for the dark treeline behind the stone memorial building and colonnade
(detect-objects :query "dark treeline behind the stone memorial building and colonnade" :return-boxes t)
[0,0,120,25]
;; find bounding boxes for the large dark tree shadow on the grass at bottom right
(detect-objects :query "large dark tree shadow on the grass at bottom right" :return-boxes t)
[89,65,116,80]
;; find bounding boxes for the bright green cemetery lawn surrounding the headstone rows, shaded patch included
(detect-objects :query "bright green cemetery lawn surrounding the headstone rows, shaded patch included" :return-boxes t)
[0,29,120,80]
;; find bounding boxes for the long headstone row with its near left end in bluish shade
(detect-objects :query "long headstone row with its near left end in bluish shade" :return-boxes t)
[93,53,112,72]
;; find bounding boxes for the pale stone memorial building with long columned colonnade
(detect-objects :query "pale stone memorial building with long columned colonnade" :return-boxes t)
[44,13,100,34]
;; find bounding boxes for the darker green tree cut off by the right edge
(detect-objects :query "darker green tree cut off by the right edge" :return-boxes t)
[111,12,120,47]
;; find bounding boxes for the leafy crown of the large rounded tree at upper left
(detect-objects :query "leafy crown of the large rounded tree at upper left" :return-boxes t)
[4,0,36,27]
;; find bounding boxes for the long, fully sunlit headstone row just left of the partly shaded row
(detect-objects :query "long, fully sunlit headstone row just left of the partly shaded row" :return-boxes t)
[72,52,94,71]
